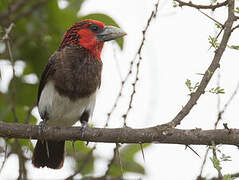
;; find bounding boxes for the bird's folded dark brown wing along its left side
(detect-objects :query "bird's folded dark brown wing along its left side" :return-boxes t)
[37,54,56,104]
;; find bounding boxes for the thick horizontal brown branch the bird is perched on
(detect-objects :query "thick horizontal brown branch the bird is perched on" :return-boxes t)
[0,122,239,145]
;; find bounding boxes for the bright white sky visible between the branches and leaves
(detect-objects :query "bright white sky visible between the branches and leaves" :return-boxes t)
[0,0,239,180]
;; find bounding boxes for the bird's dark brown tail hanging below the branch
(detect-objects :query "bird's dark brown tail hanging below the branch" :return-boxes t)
[32,140,65,169]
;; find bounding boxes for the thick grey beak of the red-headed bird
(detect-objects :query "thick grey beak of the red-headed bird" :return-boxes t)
[97,26,126,41]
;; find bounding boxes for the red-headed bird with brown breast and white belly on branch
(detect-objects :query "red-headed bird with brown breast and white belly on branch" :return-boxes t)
[32,19,126,169]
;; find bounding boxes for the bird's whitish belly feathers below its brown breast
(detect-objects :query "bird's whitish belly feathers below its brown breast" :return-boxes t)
[38,81,96,126]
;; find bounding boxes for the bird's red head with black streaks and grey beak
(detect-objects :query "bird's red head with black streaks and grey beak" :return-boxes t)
[60,19,126,59]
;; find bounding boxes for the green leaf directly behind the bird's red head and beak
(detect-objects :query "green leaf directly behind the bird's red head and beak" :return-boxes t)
[80,13,124,50]
